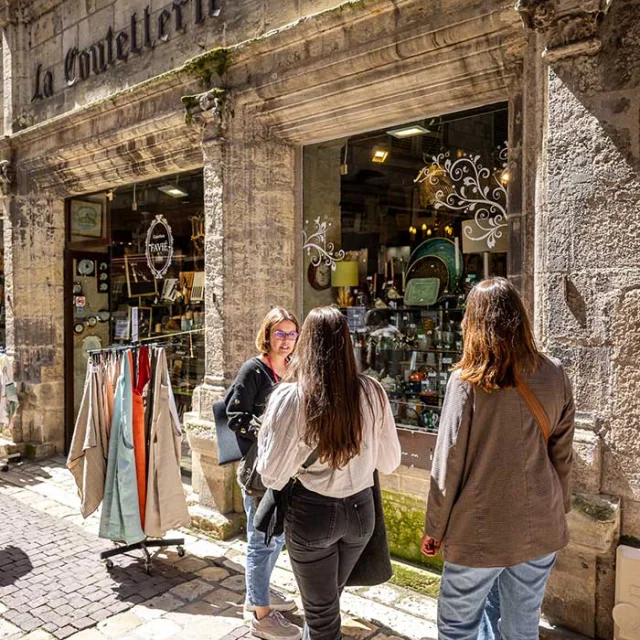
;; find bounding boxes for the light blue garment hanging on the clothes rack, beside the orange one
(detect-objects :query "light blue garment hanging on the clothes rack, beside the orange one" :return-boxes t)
[99,353,146,544]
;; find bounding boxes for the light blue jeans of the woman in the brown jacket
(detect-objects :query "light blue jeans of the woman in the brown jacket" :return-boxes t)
[438,553,556,640]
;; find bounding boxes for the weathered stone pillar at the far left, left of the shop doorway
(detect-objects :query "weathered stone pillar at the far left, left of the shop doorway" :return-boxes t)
[4,188,65,458]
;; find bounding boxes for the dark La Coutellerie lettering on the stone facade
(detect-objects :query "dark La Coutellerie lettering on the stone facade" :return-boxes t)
[31,0,220,102]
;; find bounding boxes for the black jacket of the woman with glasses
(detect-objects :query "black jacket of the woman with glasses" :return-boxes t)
[225,357,276,456]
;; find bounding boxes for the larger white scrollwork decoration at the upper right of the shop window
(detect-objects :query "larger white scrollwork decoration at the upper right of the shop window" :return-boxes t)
[414,145,509,249]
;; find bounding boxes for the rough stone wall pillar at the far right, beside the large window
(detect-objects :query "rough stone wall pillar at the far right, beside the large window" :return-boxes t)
[518,0,640,638]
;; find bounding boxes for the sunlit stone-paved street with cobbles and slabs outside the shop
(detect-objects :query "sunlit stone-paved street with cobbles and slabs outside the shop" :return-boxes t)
[0,458,437,640]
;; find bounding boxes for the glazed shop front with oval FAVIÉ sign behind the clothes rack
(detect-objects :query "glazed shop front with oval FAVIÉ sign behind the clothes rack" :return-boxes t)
[65,170,204,475]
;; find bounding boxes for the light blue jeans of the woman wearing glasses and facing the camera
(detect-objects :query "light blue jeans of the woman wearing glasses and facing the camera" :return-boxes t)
[242,491,284,607]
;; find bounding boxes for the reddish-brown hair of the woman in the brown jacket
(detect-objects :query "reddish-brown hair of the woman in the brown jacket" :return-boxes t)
[455,278,539,391]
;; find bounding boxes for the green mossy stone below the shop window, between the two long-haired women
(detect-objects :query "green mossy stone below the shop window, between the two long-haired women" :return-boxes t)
[382,490,442,571]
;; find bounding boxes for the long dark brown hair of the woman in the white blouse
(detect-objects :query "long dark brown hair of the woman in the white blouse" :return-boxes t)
[286,307,384,469]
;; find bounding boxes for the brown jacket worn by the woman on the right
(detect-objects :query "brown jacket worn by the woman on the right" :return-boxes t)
[425,356,575,567]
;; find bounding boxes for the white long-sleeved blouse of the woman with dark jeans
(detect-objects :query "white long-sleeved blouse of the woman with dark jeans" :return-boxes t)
[258,379,401,498]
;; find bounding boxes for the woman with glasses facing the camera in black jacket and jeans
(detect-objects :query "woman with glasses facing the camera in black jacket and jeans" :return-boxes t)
[226,307,300,640]
